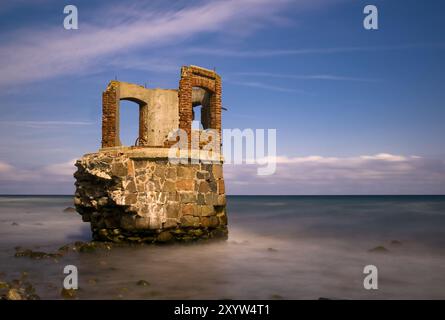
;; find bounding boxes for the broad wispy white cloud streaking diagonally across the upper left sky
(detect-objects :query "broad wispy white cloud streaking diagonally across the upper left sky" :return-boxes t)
[0,0,294,86]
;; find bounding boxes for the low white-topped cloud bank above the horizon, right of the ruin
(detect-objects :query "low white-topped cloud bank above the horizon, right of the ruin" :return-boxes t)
[225,153,445,194]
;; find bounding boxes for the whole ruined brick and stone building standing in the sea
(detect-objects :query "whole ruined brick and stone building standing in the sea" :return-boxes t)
[74,66,227,242]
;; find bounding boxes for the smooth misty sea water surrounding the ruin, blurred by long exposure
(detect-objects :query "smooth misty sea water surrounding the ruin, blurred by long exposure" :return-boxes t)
[0,196,445,299]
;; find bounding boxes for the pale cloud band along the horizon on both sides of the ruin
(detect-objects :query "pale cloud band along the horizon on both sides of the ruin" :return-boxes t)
[0,153,445,195]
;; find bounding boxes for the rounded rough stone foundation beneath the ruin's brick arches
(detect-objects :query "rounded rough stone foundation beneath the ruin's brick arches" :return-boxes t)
[74,148,227,243]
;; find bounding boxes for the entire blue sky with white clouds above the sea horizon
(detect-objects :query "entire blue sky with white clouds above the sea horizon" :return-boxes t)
[0,0,445,195]
